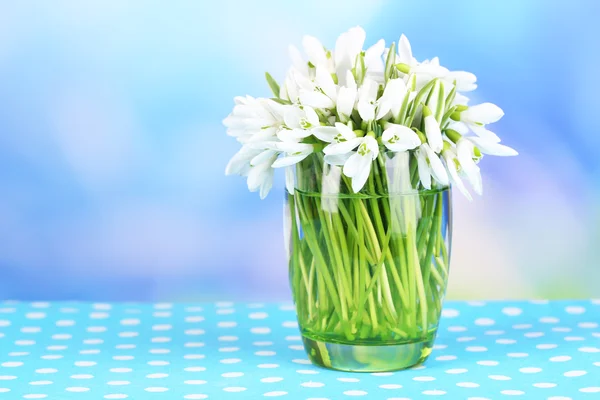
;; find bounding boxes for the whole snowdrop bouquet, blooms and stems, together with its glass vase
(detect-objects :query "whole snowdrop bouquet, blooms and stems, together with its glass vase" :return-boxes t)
[223,27,517,371]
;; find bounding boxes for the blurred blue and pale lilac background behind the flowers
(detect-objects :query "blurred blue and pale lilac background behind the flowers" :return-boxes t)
[0,0,600,301]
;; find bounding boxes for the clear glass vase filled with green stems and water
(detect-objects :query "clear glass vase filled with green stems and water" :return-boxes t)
[285,153,451,372]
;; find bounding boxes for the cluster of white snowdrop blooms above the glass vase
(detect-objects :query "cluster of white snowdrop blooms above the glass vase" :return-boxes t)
[223,27,517,199]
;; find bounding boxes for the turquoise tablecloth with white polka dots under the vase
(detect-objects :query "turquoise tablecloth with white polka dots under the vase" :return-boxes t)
[0,301,600,400]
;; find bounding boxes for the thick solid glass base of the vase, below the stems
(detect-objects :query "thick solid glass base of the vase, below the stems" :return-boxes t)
[302,334,435,372]
